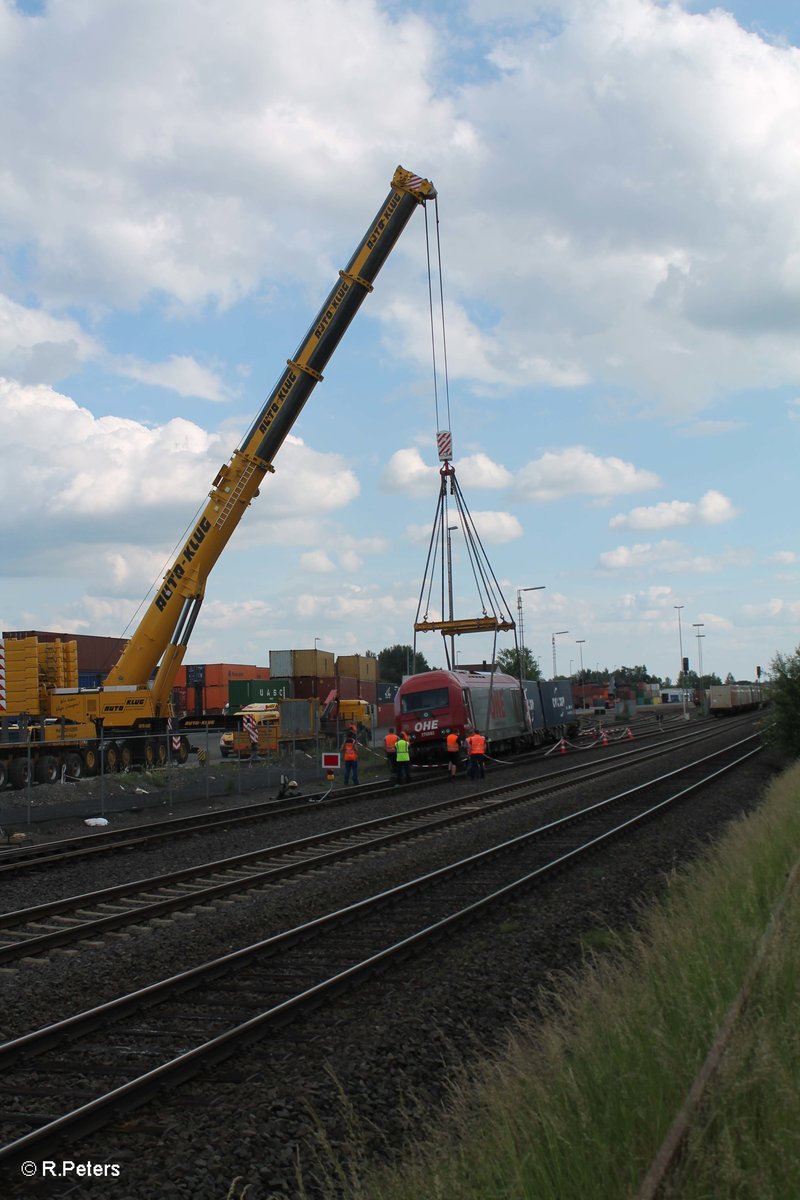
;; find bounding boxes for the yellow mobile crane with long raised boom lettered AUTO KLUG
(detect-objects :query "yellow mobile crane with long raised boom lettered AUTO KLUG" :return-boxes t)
[0,167,437,787]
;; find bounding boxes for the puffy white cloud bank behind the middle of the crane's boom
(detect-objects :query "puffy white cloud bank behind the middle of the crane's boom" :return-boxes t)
[0,380,359,566]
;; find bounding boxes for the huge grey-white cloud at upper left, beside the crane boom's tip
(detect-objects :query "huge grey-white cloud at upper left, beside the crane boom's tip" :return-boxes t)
[0,0,470,306]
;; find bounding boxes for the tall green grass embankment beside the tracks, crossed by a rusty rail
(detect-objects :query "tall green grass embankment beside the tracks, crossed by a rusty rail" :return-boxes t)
[350,766,800,1200]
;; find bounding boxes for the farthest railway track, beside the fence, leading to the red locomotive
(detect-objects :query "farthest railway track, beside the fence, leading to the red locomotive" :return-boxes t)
[0,719,753,880]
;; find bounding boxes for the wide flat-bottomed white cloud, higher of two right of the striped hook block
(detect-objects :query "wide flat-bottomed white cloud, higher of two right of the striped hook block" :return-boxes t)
[513,446,661,500]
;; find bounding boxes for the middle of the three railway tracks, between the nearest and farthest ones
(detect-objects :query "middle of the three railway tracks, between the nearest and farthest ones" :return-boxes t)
[0,720,758,967]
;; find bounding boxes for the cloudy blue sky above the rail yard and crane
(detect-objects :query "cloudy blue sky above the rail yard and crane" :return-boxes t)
[0,0,800,678]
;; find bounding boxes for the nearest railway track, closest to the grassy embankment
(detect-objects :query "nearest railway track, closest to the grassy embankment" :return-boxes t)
[0,734,760,1165]
